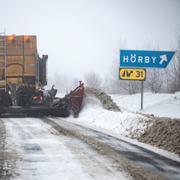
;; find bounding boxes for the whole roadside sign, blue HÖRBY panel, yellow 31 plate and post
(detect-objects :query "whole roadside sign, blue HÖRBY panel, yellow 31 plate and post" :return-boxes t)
[119,50,175,110]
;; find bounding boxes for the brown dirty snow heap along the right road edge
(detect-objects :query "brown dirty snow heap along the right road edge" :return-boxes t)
[138,118,180,156]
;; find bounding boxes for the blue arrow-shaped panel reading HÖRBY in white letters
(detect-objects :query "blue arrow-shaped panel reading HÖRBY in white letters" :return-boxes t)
[120,50,175,68]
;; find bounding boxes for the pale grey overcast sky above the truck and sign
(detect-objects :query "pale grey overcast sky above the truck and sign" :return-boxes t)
[0,0,180,79]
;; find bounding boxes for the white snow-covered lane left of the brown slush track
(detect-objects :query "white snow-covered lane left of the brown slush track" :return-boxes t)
[0,118,131,180]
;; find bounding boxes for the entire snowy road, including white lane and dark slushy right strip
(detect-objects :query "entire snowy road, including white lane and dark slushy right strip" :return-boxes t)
[0,118,180,180]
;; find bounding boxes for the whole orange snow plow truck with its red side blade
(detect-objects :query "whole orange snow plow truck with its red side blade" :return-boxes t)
[0,35,84,117]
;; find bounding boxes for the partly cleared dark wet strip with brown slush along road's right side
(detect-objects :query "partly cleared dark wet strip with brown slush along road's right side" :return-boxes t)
[44,118,180,180]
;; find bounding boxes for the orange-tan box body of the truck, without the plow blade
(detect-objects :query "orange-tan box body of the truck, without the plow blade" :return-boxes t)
[0,35,48,106]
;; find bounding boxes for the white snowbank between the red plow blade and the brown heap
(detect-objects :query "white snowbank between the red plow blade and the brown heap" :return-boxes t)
[76,94,152,137]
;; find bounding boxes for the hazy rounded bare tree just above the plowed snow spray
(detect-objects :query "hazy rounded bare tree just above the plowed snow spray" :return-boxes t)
[85,72,102,88]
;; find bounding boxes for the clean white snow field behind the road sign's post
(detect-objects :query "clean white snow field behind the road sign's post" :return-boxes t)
[111,92,180,118]
